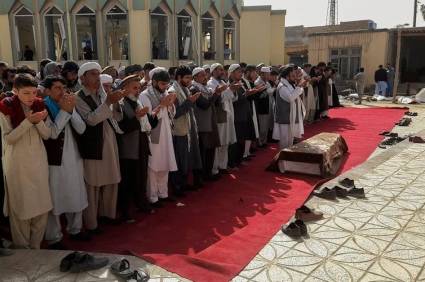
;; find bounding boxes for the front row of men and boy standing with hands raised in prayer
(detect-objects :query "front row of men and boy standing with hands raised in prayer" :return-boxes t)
[0,59,338,248]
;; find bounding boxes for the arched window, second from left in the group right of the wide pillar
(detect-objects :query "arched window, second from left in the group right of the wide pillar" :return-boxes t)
[177,10,194,60]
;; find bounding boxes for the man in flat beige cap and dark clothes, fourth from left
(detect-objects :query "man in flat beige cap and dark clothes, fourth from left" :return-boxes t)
[114,75,158,218]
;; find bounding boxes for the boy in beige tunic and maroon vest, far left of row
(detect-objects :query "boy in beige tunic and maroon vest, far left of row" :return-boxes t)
[0,74,52,249]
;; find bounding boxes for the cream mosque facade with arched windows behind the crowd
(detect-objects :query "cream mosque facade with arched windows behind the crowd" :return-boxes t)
[0,0,285,68]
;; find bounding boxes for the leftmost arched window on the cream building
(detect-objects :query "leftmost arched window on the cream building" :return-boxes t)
[13,6,37,61]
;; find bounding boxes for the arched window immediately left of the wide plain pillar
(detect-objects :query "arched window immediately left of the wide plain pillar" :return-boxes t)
[106,5,129,61]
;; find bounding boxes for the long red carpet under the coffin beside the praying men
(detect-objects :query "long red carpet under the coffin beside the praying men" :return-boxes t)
[69,108,405,281]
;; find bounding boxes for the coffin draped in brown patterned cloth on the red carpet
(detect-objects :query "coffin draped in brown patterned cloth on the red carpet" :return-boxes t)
[268,133,348,177]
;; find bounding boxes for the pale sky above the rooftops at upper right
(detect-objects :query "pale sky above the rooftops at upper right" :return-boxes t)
[244,0,425,28]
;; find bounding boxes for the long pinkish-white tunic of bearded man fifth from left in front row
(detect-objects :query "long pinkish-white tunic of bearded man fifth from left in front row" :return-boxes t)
[139,93,177,172]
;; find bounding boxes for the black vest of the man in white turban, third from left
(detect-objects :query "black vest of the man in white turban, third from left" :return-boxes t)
[77,90,103,160]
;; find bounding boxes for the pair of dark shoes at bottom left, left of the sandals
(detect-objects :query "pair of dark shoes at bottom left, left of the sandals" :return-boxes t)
[60,252,109,273]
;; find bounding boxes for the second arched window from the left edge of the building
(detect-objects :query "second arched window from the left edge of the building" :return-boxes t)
[44,6,68,61]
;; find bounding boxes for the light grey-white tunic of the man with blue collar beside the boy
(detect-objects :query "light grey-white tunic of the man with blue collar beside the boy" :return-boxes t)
[46,110,87,215]
